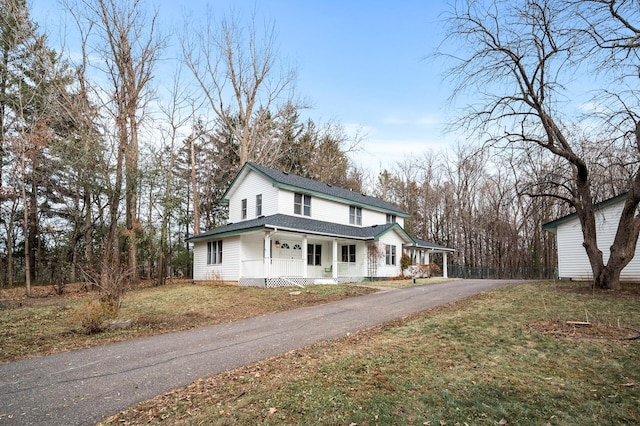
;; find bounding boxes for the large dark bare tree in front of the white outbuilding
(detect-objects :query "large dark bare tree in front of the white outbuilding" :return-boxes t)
[441,0,640,289]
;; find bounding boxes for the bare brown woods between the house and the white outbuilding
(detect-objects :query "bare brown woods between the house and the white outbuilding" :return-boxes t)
[375,145,625,279]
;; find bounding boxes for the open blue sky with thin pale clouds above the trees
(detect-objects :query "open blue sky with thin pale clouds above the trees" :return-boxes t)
[31,0,455,172]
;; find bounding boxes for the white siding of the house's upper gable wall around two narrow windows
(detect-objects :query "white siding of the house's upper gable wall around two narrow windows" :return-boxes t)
[229,171,280,223]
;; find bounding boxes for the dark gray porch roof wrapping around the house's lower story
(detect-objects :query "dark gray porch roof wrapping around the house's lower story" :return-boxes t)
[187,214,414,243]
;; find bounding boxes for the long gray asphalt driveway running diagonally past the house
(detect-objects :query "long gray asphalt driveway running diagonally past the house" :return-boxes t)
[0,280,521,425]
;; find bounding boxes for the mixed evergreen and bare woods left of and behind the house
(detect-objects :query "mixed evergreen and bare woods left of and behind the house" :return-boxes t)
[0,0,360,293]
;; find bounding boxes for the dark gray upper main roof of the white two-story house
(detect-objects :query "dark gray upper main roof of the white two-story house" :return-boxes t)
[230,162,409,217]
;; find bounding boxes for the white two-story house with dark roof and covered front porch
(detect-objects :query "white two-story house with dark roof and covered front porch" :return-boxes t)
[190,163,453,287]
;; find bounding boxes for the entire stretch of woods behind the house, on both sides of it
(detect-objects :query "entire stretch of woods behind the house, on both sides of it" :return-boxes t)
[0,0,640,293]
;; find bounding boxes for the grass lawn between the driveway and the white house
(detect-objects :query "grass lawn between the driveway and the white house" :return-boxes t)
[0,283,375,362]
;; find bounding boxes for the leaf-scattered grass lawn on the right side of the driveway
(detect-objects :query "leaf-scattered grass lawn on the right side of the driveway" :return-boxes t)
[101,282,640,426]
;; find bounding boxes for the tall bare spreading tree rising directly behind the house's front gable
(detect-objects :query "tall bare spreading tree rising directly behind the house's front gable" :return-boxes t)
[182,8,295,165]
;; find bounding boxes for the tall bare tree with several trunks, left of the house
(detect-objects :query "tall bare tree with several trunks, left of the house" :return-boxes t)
[78,0,163,280]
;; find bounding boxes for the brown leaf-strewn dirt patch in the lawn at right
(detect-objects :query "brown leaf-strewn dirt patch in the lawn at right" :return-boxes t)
[527,321,640,341]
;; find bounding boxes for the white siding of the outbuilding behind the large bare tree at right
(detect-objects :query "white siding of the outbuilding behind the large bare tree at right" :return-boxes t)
[556,200,640,281]
